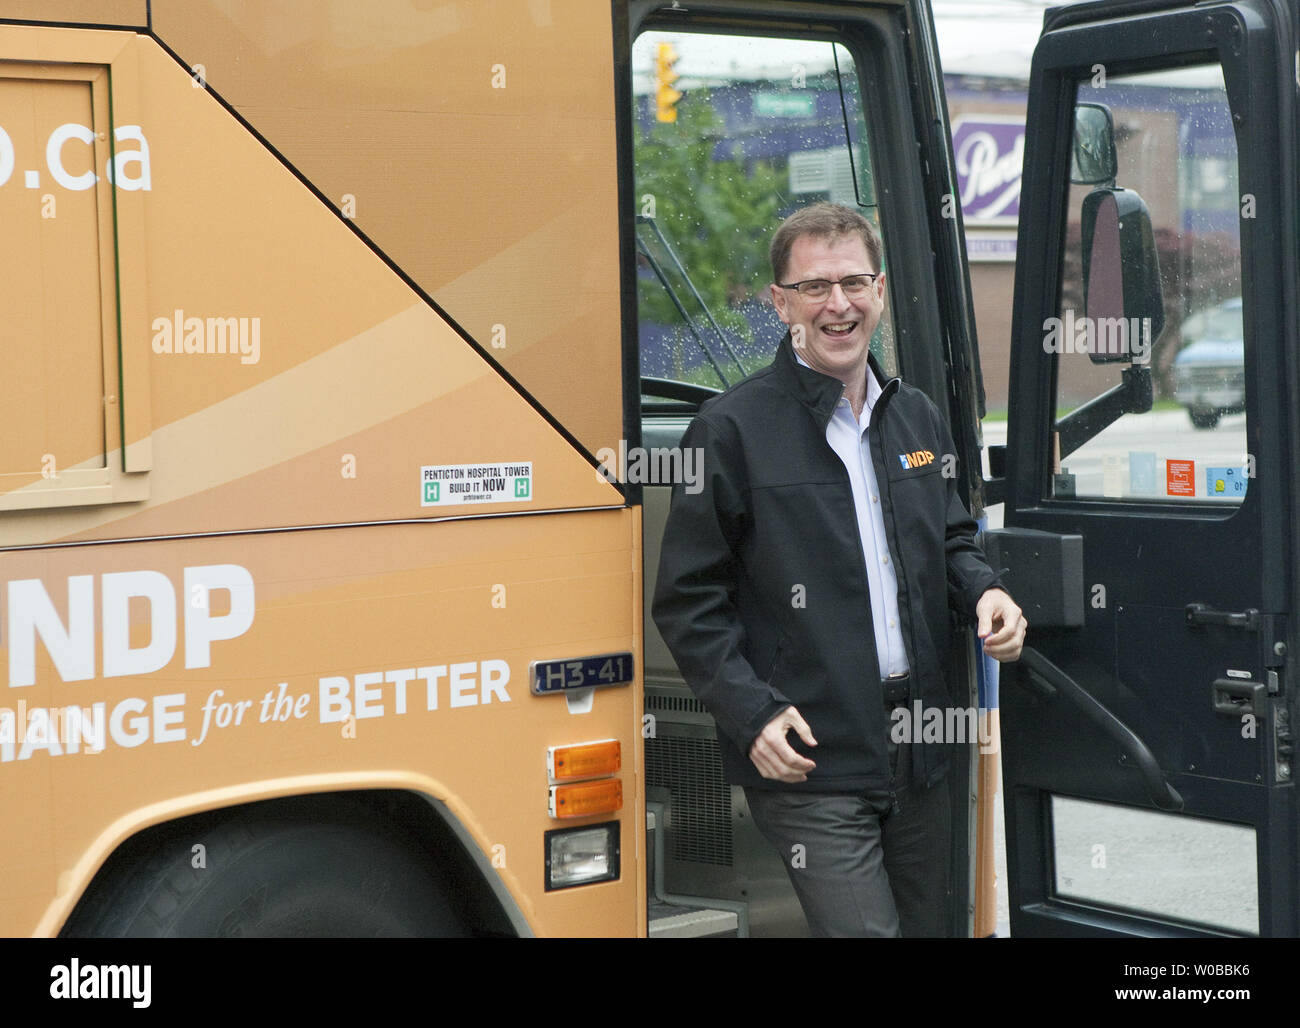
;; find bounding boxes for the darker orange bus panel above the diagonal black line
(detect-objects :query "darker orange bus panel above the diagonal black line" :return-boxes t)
[152,0,623,454]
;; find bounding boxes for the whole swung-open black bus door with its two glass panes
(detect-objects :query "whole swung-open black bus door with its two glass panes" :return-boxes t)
[989,0,1300,936]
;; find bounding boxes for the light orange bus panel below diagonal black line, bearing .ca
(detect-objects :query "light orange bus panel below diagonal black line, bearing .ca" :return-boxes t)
[0,27,619,545]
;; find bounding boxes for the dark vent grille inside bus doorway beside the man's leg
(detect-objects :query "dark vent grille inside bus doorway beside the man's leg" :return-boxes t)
[646,732,732,867]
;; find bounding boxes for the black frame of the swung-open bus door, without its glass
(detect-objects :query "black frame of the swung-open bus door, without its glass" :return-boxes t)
[1001,0,1300,936]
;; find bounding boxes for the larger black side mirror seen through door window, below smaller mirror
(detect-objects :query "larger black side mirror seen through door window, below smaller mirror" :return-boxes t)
[1079,188,1165,364]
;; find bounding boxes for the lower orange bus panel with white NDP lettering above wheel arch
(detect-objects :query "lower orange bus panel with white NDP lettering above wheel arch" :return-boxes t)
[0,509,641,934]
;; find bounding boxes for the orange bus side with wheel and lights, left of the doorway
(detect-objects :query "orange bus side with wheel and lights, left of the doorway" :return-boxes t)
[0,0,660,936]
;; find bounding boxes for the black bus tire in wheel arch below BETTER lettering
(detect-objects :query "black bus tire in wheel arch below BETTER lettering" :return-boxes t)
[62,801,469,938]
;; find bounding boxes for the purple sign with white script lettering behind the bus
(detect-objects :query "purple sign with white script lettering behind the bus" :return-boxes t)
[953,114,1024,227]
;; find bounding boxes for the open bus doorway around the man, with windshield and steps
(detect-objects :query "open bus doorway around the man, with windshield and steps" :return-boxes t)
[626,0,982,937]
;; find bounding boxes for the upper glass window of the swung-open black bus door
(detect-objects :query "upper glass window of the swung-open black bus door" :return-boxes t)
[1043,64,1255,504]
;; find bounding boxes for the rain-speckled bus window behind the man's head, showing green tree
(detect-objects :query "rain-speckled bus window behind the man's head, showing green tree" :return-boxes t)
[633,31,897,403]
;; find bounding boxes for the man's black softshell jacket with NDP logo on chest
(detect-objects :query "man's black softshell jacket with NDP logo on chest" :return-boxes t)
[653,335,1000,791]
